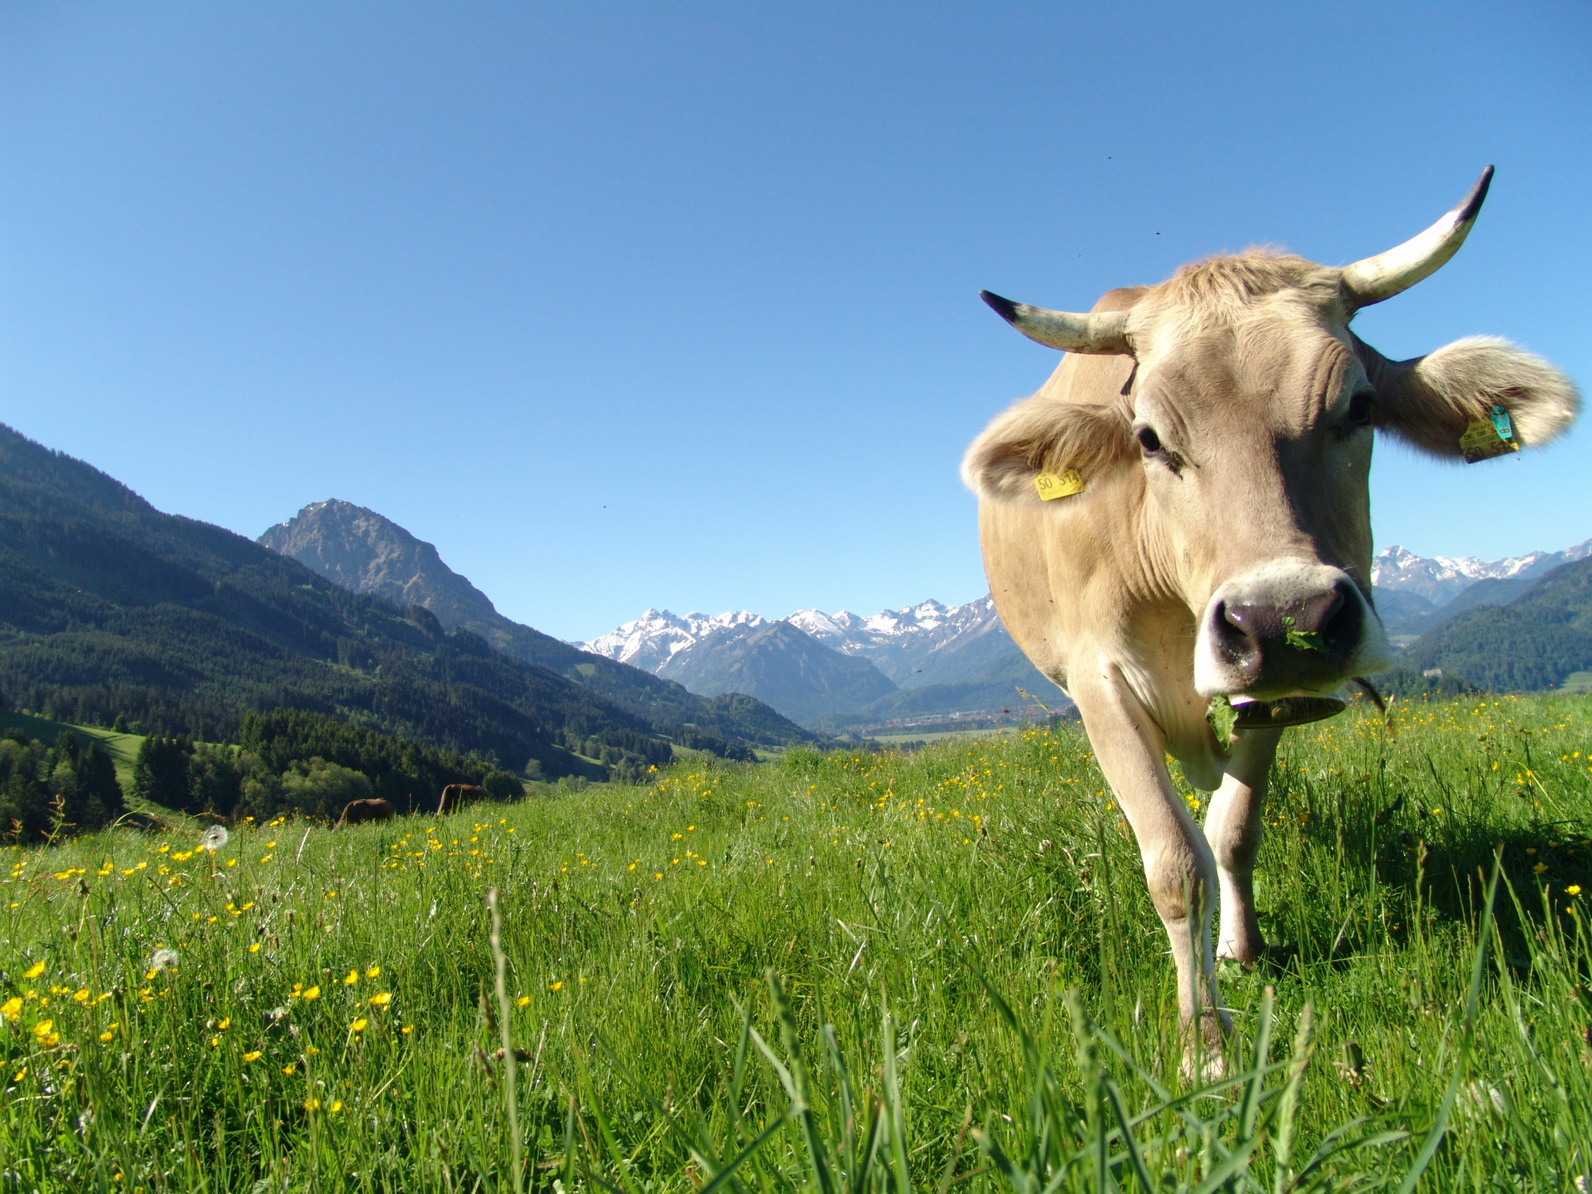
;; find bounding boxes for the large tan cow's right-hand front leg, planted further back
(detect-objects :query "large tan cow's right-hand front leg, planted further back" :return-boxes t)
[1205,729,1283,962]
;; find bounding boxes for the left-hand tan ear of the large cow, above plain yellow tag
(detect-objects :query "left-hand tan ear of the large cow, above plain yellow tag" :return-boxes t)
[962,395,1138,505]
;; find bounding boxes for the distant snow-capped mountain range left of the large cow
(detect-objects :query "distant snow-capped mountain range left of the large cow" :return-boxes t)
[581,597,1016,688]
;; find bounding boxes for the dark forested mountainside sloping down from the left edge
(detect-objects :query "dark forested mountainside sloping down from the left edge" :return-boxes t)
[0,425,804,777]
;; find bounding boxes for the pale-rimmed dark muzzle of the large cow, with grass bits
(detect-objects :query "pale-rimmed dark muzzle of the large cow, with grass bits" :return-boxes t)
[1194,560,1387,699]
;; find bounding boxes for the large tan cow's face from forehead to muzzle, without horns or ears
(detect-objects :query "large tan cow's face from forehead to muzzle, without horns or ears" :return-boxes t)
[1124,281,1388,697]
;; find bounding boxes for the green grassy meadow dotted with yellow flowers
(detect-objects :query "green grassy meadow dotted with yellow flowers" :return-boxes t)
[0,697,1592,1194]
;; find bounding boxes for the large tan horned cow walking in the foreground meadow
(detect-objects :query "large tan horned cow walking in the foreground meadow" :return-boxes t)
[962,166,1579,1052]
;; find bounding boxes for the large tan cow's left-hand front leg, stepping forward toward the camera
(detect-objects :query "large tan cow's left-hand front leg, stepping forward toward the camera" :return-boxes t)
[1073,667,1229,1051]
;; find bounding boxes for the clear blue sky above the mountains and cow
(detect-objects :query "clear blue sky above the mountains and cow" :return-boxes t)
[0,3,1592,638]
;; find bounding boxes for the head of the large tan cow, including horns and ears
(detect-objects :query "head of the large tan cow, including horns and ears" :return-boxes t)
[963,167,1579,697]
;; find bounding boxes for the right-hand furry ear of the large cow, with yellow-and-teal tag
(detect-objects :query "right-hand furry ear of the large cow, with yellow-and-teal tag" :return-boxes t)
[1358,336,1581,458]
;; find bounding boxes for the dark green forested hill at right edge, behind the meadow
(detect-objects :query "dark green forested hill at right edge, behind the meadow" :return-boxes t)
[1401,559,1592,693]
